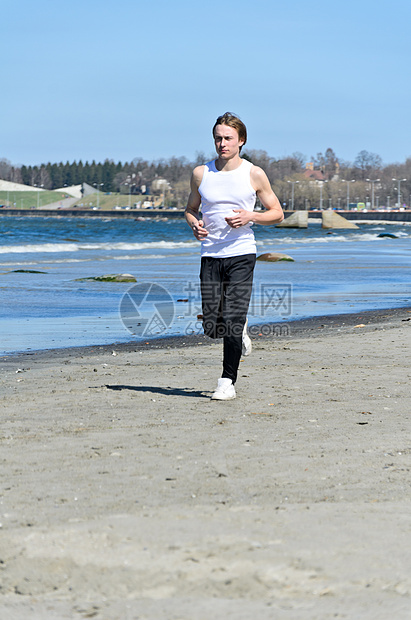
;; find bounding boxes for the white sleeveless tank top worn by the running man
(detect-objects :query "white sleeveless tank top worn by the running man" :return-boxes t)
[198,159,257,258]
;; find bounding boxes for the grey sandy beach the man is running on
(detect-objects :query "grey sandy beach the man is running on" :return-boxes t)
[0,309,411,620]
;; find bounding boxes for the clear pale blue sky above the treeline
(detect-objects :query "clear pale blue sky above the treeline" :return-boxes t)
[0,0,411,164]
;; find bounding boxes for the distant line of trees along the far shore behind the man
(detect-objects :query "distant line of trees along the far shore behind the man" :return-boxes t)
[0,148,411,206]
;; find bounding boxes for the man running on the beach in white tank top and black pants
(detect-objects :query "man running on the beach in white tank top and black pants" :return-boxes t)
[185,112,284,400]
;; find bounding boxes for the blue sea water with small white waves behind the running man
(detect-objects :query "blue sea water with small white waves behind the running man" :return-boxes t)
[0,216,411,354]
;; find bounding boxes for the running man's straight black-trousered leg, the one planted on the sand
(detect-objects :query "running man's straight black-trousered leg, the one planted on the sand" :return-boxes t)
[222,254,256,383]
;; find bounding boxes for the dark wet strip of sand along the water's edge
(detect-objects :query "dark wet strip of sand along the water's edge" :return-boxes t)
[0,304,411,370]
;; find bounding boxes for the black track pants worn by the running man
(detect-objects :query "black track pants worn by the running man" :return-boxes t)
[200,254,256,383]
